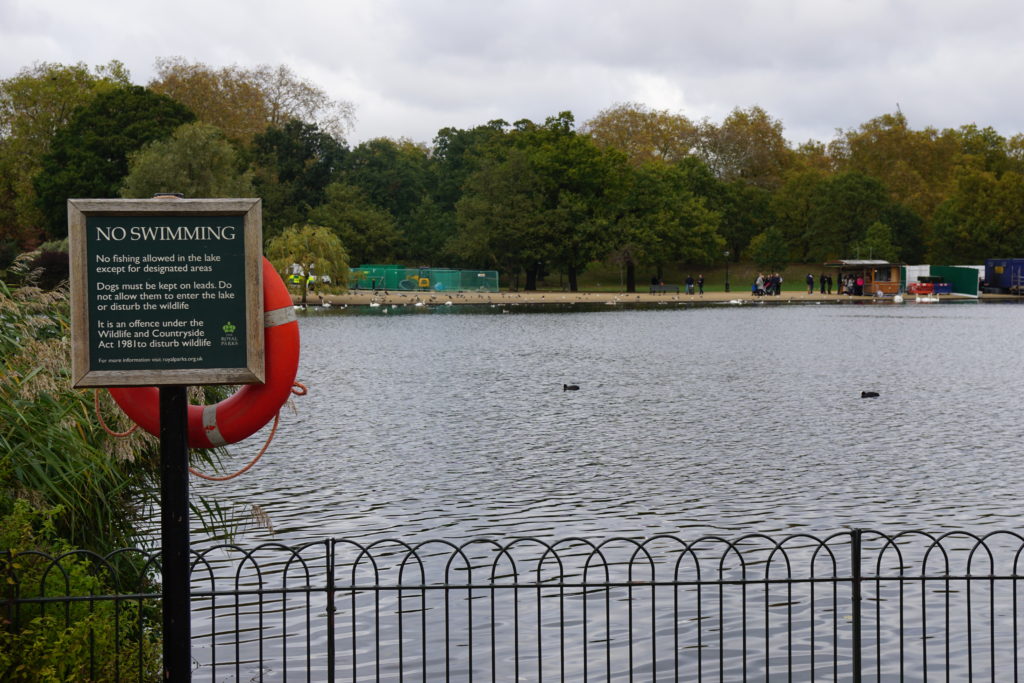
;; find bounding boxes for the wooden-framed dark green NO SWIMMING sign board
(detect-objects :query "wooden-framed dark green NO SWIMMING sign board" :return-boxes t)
[68,197,264,387]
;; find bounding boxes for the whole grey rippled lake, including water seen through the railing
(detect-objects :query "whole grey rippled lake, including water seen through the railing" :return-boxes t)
[186,303,1024,680]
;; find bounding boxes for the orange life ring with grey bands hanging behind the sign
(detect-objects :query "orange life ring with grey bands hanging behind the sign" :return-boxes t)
[109,258,299,449]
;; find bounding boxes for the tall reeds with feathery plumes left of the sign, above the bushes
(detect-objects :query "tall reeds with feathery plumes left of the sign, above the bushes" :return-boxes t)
[0,266,157,553]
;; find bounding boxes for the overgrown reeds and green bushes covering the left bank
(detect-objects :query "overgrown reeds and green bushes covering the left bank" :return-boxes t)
[0,254,245,681]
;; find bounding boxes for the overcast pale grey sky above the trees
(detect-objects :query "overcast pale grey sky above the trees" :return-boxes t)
[0,0,1024,143]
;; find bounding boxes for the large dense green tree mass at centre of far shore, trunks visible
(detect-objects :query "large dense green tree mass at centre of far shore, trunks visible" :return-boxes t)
[450,112,720,291]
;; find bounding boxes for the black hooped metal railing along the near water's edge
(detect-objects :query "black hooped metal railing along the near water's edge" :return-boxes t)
[0,529,1024,681]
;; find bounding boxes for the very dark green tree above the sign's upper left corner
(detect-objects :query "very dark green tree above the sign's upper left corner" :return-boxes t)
[35,86,196,238]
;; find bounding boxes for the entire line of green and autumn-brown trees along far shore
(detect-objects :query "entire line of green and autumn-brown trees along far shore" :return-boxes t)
[0,58,1024,290]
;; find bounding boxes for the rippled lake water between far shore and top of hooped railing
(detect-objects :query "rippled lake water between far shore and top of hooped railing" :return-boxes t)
[195,303,1024,543]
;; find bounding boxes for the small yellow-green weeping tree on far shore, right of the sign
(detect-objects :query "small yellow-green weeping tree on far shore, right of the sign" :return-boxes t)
[264,225,348,304]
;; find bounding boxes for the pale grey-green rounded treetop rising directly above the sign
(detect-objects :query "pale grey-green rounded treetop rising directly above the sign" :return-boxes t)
[121,123,254,199]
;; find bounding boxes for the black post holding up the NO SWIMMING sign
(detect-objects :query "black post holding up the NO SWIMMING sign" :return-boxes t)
[160,386,191,681]
